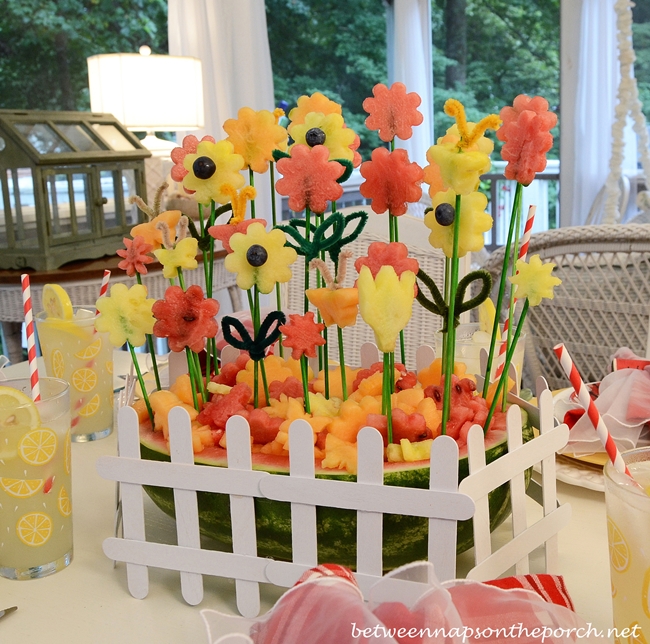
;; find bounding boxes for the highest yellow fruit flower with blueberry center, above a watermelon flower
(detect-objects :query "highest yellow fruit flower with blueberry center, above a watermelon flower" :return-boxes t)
[289,112,356,162]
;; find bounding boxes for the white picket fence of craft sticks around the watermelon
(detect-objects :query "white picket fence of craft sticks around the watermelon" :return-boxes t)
[97,354,571,617]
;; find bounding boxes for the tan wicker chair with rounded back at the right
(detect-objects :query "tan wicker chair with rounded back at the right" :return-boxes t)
[484,224,650,389]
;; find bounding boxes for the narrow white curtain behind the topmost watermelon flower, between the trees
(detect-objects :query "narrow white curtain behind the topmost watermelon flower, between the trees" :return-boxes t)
[387,0,435,166]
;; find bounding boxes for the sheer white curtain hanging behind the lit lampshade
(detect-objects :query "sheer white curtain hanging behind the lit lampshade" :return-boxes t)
[166,0,275,236]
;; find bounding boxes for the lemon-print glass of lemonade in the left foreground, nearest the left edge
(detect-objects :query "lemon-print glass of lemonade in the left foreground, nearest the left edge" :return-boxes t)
[0,378,72,579]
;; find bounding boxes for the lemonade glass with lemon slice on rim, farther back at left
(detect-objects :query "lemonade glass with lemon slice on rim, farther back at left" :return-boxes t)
[36,305,113,443]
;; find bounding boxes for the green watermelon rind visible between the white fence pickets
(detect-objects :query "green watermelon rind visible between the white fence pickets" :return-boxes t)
[140,416,533,570]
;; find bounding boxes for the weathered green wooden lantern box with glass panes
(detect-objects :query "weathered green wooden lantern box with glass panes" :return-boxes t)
[0,110,150,271]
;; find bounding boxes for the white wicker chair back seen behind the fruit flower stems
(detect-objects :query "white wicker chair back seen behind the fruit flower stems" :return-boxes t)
[283,206,469,369]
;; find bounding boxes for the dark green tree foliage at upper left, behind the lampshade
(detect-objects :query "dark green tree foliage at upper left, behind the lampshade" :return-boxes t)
[0,0,167,110]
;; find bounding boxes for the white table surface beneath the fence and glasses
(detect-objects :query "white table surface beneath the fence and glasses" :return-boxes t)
[0,354,612,644]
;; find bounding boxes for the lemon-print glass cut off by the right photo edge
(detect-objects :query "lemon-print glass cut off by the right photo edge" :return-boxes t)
[605,447,650,644]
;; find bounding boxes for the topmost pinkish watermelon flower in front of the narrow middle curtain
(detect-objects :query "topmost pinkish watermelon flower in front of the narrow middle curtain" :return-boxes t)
[363,83,424,142]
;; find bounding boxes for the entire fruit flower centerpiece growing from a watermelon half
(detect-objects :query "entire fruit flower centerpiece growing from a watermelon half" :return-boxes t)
[96,83,559,567]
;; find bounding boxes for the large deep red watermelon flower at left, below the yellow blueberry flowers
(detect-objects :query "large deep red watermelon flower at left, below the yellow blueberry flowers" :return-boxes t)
[152,285,219,352]
